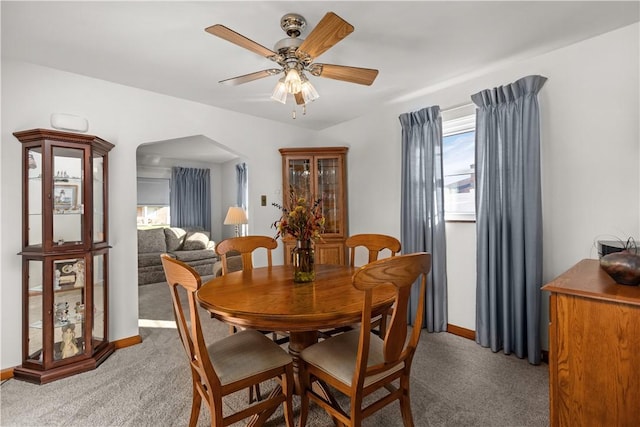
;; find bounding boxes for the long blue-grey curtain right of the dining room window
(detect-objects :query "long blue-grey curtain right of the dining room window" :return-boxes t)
[471,76,546,364]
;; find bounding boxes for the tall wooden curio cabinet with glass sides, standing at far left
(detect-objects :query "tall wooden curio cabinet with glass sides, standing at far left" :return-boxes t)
[13,129,114,384]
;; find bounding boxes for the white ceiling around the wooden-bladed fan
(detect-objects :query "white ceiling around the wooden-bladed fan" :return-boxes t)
[2,1,640,161]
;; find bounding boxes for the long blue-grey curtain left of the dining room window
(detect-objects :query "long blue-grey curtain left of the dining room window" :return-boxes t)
[399,106,447,332]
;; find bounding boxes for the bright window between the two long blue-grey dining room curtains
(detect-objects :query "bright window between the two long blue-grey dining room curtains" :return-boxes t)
[442,112,476,221]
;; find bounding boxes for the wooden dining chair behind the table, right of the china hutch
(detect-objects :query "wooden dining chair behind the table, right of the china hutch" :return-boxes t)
[345,233,402,334]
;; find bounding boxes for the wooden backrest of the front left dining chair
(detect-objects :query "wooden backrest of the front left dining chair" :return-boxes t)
[160,254,221,396]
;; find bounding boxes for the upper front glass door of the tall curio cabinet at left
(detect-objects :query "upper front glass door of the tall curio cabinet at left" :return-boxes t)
[51,146,84,245]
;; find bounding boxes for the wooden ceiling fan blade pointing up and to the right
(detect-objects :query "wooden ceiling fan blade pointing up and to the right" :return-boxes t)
[296,12,353,59]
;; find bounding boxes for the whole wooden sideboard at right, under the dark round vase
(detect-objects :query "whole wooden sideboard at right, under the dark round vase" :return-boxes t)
[542,259,640,426]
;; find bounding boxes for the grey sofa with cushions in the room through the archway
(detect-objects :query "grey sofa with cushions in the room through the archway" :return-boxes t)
[138,227,218,285]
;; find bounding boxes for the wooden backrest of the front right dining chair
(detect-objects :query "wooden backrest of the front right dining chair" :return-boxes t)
[353,252,431,385]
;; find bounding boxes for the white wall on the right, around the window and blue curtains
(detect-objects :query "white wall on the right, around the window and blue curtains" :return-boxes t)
[320,24,640,338]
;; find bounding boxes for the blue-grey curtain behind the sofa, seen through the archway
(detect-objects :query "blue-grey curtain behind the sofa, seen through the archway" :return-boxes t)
[170,167,211,232]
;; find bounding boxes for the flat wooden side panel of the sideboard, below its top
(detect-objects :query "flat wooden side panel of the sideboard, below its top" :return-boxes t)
[555,295,640,426]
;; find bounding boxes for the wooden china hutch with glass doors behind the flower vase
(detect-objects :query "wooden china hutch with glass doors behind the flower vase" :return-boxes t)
[280,147,348,264]
